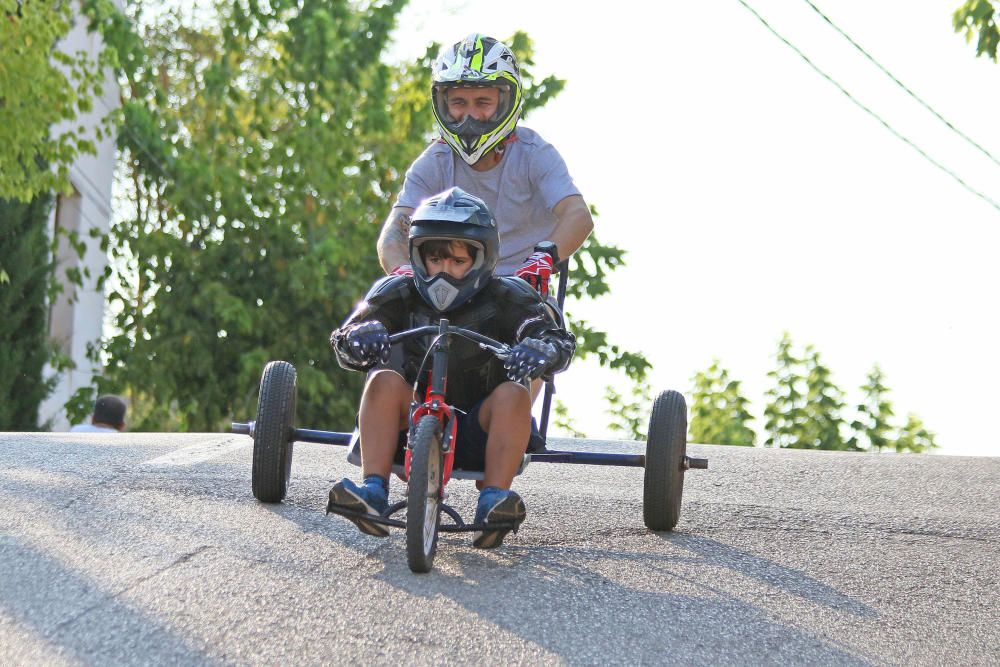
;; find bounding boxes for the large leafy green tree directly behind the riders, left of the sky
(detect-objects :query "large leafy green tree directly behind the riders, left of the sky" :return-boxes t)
[82,0,648,430]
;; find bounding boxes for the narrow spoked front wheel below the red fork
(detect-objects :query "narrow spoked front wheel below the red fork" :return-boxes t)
[406,415,444,572]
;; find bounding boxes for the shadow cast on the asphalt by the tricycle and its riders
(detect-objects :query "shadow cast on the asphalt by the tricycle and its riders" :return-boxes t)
[373,535,873,665]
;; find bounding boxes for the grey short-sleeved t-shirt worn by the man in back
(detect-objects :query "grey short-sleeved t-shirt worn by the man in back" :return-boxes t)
[395,126,580,275]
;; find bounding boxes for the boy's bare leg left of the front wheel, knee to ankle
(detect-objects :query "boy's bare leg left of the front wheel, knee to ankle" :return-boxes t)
[358,370,413,479]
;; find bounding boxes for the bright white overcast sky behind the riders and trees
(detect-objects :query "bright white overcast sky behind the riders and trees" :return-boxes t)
[390,0,1000,456]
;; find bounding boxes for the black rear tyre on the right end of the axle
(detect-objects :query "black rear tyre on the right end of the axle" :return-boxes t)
[642,391,687,531]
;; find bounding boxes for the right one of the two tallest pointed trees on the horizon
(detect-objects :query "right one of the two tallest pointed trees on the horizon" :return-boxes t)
[796,345,848,450]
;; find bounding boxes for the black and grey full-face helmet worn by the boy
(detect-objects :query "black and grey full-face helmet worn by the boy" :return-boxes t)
[410,188,500,313]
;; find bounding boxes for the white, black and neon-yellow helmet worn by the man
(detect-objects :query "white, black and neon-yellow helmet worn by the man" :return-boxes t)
[431,33,523,164]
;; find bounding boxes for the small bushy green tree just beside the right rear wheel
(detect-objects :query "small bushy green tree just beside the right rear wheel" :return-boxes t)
[689,359,756,447]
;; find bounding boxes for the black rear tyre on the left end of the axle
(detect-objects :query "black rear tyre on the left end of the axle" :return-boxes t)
[251,361,296,503]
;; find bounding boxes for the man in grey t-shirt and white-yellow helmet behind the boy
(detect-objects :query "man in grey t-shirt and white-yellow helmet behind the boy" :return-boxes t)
[378,34,594,296]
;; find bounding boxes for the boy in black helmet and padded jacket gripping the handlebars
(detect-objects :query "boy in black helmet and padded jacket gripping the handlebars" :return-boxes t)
[330,188,576,548]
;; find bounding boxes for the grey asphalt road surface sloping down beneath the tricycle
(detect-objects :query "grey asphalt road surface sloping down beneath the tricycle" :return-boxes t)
[0,433,1000,666]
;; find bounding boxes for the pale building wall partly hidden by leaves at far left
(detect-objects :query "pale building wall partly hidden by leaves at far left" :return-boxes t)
[39,0,121,431]
